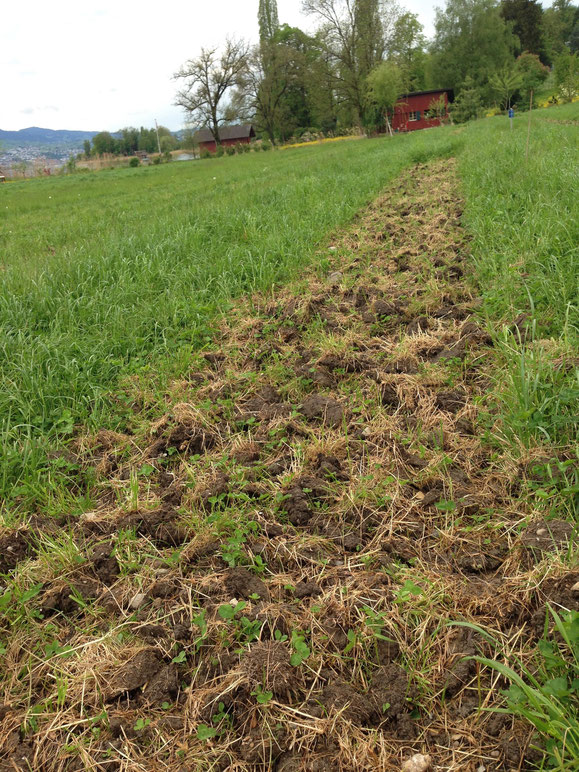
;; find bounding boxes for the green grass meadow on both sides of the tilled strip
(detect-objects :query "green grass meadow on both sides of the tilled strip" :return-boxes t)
[0,104,579,501]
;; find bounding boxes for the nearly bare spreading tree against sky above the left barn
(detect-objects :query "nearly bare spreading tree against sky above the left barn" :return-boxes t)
[174,38,249,145]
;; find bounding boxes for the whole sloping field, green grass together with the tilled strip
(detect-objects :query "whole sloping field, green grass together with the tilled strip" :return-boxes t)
[0,106,579,772]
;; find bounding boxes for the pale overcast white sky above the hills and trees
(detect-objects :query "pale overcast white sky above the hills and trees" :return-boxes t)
[0,0,444,131]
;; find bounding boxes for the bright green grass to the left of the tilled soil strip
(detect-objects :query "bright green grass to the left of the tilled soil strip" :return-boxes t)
[0,130,457,498]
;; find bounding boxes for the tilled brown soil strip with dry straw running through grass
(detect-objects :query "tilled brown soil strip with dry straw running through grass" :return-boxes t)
[0,160,579,772]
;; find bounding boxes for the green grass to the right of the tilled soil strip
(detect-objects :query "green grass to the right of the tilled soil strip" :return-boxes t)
[460,112,579,456]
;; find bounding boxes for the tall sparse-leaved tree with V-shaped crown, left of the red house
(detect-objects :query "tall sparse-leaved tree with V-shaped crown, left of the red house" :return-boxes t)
[302,0,397,124]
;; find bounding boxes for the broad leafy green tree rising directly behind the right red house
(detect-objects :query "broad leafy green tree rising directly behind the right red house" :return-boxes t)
[432,0,517,93]
